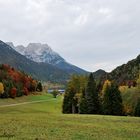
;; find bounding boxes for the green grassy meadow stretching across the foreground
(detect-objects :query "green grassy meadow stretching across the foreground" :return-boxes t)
[0,94,140,140]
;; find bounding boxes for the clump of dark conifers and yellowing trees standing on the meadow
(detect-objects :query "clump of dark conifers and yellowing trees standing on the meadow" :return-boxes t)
[62,73,140,116]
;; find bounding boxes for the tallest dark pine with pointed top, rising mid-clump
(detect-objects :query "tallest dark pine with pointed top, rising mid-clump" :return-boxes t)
[85,73,100,114]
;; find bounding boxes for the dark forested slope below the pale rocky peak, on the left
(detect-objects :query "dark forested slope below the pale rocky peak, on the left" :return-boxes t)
[0,41,70,82]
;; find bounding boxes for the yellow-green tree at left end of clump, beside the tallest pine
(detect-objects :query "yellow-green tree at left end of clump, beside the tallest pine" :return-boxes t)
[62,75,86,113]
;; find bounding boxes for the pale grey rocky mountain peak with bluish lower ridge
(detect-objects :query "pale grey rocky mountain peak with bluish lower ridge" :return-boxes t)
[7,42,87,74]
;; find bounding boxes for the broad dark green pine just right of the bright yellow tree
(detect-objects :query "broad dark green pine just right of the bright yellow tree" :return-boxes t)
[103,83,123,115]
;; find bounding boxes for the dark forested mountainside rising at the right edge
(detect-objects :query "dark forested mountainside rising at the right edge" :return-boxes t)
[108,55,140,84]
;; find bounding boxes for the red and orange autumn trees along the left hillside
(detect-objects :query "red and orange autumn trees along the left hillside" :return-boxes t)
[0,64,42,98]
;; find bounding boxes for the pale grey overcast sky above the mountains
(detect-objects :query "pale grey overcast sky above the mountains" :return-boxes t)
[0,0,140,71]
